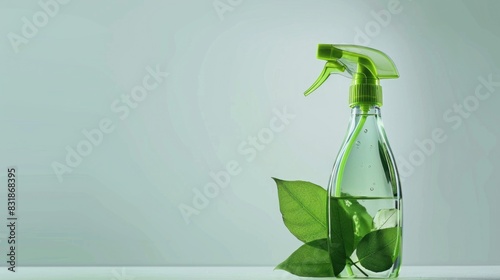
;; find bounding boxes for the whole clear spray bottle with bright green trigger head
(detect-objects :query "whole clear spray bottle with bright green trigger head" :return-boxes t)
[304,44,402,278]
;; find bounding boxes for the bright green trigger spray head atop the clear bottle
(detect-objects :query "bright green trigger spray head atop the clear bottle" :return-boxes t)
[304,44,399,107]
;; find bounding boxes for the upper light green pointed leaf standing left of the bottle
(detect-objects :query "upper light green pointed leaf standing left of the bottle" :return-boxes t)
[273,178,328,243]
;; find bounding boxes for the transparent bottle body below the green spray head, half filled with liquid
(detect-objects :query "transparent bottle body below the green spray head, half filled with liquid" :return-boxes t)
[328,106,402,278]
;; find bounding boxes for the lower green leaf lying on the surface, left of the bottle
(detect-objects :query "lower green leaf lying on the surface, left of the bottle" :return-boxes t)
[276,239,333,277]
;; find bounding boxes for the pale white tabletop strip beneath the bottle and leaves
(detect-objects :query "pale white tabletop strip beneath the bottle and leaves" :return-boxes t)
[0,266,500,280]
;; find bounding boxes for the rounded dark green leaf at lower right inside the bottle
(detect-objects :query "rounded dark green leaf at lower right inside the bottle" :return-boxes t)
[356,227,401,272]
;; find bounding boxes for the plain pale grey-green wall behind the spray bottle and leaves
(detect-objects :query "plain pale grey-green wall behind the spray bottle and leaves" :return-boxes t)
[0,0,500,265]
